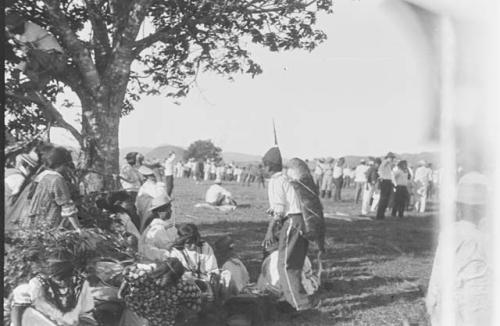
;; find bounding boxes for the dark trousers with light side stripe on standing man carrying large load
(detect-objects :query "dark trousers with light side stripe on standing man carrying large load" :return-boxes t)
[278,214,311,310]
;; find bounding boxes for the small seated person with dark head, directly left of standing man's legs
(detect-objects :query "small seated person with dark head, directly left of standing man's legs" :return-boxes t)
[214,236,250,299]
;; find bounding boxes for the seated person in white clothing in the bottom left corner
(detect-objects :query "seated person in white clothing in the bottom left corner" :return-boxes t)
[11,250,97,326]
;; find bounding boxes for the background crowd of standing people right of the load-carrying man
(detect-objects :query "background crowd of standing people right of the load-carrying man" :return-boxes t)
[310,153,439,218]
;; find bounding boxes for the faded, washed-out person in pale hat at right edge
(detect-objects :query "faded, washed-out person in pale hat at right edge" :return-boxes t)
[425,172,493,326]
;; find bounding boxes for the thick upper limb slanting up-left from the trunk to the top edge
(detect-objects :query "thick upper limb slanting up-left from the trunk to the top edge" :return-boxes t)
[44,0,101,93]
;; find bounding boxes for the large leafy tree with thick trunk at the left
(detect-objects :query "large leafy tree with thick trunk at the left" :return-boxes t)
[6,0,332,188]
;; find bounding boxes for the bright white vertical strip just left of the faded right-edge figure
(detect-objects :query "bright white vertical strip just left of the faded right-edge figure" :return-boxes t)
[439,16,457,325]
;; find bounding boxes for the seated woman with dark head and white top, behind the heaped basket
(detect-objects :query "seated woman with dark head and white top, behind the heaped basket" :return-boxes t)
[171,223,219,300]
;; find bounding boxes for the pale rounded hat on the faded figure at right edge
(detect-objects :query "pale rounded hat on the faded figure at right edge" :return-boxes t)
[456,172,488,205]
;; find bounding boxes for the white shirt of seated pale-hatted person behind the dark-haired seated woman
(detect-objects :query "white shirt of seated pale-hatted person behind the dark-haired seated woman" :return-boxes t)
[138,218,177,260]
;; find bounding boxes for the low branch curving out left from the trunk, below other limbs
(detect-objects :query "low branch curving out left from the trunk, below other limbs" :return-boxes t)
[5,91,83,146]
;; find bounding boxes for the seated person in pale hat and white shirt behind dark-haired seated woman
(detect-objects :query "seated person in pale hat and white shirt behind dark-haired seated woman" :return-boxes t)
[139,192,177,261]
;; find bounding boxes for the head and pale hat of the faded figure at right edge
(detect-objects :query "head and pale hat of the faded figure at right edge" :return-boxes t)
[456,172,488,224]
